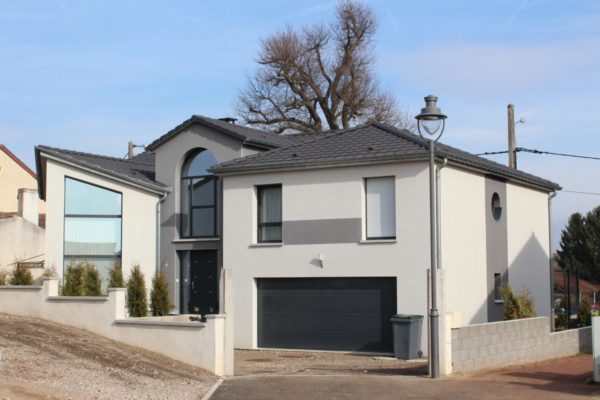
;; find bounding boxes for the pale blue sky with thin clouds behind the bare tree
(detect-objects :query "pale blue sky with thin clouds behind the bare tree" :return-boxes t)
[0,0,600,252]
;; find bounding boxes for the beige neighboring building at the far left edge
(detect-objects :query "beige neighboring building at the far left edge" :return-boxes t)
[0,144,46,277]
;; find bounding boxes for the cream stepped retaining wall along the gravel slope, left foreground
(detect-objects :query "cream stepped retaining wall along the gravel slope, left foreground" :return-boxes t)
[0,278,233,375]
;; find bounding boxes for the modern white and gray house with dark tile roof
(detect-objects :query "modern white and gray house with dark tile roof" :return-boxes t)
[31,116,560,351]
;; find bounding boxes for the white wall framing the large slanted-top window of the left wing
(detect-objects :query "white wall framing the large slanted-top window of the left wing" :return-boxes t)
[46,160,158,291]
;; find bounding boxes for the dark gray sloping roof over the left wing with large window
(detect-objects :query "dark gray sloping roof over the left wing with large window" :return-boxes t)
[35,145,167,196]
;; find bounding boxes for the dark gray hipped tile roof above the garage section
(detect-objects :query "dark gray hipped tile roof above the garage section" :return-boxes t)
[213,123,561,190]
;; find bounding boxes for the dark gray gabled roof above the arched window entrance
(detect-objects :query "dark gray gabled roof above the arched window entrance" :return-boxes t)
[146,115,293,151]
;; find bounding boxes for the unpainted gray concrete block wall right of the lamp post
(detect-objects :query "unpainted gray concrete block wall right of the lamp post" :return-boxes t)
[451,317,592,373]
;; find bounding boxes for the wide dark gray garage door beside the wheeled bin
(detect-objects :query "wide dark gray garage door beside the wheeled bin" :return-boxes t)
[257,278,396,352]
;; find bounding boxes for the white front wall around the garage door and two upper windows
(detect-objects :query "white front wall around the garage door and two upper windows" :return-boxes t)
[223,163,429,351]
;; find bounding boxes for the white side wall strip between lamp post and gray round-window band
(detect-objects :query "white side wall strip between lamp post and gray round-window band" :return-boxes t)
[440,167,487,326]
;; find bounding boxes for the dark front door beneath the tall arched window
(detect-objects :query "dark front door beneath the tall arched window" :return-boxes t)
[181,250,219,315]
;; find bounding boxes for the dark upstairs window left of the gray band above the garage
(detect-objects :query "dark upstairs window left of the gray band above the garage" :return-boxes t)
[257,185,281,243]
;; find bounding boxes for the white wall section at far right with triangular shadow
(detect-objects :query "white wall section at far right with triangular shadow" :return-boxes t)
[507,183,550,316]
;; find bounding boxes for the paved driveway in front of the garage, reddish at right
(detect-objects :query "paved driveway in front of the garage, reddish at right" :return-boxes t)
[210,352,600,400]
